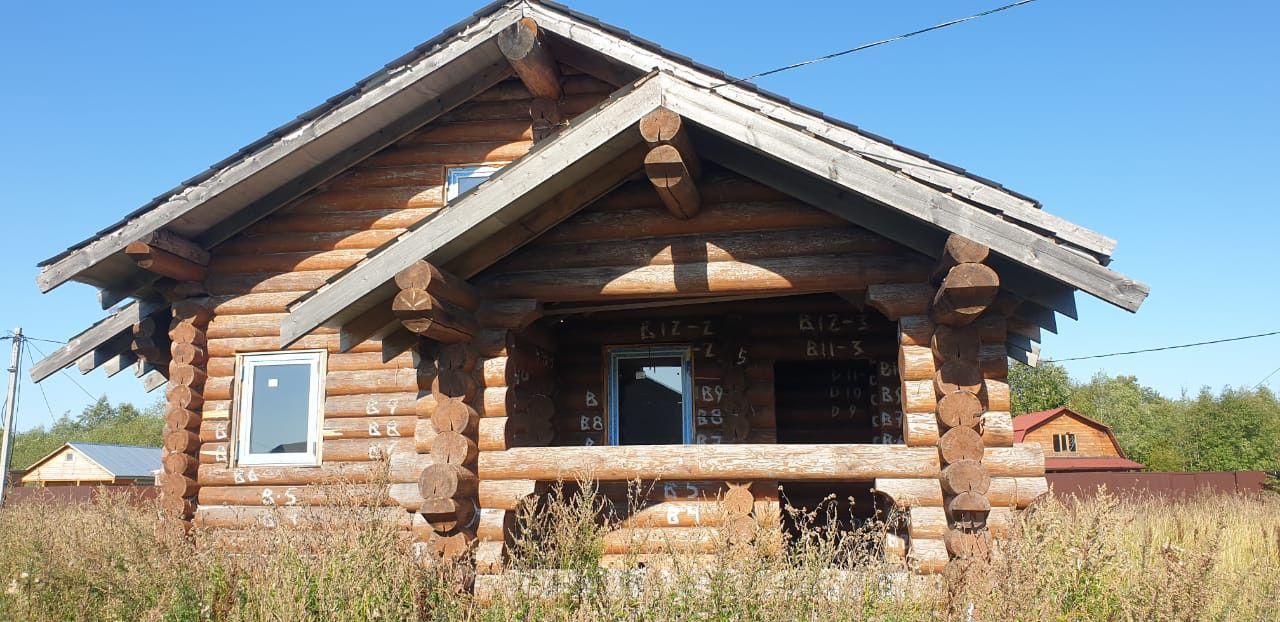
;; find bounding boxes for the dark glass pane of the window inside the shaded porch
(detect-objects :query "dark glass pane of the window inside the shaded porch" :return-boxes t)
[616,356,685,445]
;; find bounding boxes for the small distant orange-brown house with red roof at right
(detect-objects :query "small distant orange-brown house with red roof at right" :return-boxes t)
[1014,407,1144,472]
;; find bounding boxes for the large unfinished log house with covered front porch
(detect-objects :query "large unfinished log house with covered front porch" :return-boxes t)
[32,0,1147,576]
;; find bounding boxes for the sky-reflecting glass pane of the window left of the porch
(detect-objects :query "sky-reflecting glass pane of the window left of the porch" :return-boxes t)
[248,362,311,453]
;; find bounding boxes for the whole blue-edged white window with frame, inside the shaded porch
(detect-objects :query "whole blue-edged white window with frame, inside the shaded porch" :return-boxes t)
[608,346,694,445]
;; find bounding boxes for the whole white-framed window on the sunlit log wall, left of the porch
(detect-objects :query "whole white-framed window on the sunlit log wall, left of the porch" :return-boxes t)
[236,351,325,466]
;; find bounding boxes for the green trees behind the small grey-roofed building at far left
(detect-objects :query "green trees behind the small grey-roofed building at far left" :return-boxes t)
[12,395,164,468]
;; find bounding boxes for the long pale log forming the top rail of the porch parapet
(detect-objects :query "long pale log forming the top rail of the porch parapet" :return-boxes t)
[479,444,940,481]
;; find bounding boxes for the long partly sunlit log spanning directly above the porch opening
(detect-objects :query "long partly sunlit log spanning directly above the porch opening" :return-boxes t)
[479,255,925,302]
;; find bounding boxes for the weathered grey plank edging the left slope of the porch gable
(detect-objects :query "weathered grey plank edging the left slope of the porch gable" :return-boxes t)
[280,72,662,344]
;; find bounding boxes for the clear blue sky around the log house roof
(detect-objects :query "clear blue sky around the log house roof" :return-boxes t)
[0,0,1280,429]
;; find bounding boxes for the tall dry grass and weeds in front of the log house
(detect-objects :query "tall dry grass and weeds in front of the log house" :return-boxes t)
[0,493,1280,621]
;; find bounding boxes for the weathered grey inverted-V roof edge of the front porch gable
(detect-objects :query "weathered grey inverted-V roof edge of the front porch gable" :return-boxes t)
[282,69,1147,346]
